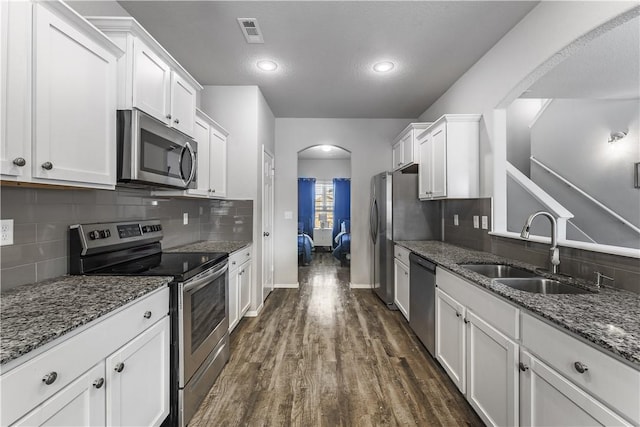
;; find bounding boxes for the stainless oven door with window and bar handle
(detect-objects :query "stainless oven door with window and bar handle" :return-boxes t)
[178,260,229,388]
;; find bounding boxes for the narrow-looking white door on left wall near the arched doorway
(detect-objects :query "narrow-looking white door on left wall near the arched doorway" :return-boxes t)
[262,150,275,301]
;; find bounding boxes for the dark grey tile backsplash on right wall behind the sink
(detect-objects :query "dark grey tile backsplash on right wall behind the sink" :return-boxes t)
[442,198,640,293]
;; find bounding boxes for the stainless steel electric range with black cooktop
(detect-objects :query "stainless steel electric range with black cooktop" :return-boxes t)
[69,220,229,426]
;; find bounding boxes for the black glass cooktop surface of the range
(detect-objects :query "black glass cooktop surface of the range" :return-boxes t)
[90,252,229,282]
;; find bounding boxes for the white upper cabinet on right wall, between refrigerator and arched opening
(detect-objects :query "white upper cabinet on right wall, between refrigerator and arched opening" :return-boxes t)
[416,114,481,200]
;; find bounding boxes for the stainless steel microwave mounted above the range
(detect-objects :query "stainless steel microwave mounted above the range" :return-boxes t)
[117,109,197,189]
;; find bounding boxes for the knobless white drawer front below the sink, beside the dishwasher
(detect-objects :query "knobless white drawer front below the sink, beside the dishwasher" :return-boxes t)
[436,267,520,339]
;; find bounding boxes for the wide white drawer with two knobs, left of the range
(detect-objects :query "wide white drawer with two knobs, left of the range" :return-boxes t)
[0,287,169,426]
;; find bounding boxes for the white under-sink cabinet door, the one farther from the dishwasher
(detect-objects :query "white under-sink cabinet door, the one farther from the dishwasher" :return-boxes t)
[465,310,518,426]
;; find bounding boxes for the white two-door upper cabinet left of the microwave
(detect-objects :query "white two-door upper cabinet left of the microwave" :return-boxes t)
[0,2,122,188]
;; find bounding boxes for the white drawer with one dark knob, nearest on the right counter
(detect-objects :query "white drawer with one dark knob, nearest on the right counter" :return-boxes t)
[522,314,640,424]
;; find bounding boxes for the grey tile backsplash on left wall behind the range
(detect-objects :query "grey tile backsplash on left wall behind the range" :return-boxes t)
[0,186,253,290]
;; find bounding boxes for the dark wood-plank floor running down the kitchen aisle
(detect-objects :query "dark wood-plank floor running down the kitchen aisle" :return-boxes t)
[189,254,482,426]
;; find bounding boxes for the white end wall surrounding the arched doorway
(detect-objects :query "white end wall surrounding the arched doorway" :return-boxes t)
[274,118,412,286]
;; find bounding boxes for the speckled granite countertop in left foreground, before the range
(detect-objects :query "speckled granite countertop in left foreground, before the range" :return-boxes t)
[0,276,172,365]
